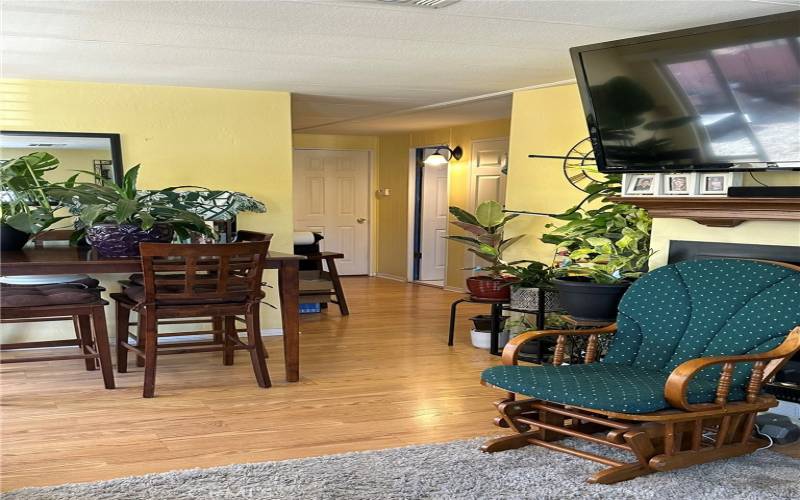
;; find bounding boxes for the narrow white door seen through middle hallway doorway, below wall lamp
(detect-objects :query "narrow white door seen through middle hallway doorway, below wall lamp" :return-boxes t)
[419,165,447,281]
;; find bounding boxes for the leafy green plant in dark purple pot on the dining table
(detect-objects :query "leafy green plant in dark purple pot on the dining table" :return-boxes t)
[48,165,213,257]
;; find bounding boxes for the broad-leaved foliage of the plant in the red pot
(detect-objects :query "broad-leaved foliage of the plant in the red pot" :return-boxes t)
[445,200,524,278]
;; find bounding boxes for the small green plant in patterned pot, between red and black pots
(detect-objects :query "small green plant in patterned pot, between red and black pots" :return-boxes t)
[504,261,560,311]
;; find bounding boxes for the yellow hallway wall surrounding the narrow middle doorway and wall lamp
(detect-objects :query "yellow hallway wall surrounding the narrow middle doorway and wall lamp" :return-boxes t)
[377,119,509,288]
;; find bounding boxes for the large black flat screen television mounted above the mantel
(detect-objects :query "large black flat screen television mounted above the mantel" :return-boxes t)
[570,11,800,172]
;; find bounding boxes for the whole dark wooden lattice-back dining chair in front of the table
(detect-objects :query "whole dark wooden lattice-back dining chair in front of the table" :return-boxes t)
[111,241,271,398]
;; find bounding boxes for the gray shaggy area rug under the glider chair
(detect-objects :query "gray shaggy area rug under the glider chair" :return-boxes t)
[3,439,800,500]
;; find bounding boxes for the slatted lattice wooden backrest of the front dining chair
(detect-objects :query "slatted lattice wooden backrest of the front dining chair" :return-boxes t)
[139,241,269,304]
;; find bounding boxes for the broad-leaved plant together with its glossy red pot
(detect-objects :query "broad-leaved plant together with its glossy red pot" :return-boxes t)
[446,201,523,300]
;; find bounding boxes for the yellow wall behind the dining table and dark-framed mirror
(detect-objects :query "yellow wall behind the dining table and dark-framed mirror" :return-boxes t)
[0,80,292,340]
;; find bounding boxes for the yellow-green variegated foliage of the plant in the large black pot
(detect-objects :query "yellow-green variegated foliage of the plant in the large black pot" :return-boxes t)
[541,203,652,284]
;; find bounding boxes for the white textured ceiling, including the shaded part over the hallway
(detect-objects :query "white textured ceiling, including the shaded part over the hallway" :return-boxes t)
[0,0,800,134]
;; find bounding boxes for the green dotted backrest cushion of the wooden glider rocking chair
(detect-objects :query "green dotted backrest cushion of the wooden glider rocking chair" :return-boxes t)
[605,259,800,382]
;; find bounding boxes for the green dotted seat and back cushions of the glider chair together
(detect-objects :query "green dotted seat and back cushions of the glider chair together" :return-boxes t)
[483,259,800,413]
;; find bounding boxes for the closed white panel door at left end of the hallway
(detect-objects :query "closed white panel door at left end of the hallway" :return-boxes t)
[293,149,369,275]
